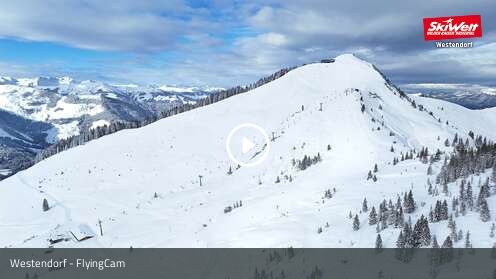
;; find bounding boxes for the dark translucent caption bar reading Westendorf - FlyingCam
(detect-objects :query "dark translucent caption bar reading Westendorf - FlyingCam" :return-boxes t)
[0,248,496,279]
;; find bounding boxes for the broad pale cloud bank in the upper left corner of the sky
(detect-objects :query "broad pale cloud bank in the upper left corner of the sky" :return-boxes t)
[0,0,202,52]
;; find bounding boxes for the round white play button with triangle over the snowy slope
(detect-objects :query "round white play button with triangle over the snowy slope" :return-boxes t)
[226,123,270,167]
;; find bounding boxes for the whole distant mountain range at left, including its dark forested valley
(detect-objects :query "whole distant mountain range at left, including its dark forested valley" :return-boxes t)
[0,77,220,178]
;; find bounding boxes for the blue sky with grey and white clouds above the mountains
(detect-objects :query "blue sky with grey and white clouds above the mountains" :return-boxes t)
[0,0,496,87]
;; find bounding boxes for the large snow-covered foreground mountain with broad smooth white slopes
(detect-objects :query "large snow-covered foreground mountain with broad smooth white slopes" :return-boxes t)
[0,55,496,247]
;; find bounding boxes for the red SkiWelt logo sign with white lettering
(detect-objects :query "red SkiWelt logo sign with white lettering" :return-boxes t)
[424,15,482,41]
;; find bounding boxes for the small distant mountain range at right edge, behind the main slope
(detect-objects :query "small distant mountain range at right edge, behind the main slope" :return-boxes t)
[402,83,496,109]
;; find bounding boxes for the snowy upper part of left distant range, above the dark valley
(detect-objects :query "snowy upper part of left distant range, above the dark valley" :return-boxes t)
[0,77,218,138]
